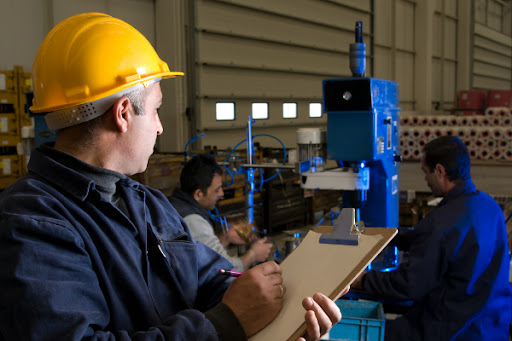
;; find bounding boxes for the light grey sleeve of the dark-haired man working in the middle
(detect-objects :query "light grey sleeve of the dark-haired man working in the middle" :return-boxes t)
[184,214,244,271]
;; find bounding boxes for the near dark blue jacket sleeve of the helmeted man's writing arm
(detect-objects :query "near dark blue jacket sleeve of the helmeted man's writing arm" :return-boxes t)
[0,215,228,340]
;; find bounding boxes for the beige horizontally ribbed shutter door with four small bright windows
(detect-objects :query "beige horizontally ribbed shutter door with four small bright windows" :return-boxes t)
[190,0,372,148]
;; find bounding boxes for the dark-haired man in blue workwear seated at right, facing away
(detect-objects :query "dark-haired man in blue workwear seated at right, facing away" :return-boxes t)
[352,136,512,341]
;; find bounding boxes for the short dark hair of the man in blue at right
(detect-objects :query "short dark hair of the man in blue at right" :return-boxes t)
[423,136,471,181]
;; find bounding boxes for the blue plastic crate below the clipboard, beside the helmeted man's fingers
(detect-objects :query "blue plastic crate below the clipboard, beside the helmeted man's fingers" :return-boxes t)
[329,299,386,341]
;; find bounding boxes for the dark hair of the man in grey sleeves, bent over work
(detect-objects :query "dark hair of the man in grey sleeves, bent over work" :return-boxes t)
[180,154,222,194]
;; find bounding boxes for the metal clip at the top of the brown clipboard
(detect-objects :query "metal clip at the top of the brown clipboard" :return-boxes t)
[319,208,364,245]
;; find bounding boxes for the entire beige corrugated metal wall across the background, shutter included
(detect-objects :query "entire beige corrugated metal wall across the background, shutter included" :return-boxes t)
[0,0,512,151]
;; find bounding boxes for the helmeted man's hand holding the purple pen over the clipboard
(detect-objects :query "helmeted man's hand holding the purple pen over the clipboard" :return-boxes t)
[222,262,284,337]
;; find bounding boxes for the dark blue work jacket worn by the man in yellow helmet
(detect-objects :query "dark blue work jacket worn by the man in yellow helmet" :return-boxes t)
[0,150,236,340]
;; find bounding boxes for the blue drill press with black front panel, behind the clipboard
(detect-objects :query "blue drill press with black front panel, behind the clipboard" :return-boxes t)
[301,22,401,271]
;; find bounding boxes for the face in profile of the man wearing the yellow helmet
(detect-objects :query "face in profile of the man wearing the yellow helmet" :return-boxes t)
[127,83,163,174]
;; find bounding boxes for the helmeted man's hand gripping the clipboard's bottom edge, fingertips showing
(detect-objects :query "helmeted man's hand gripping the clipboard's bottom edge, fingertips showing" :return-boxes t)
[297,286,350,341]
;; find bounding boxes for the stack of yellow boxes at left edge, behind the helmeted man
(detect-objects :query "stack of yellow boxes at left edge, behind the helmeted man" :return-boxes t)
[0,66,33,190]
